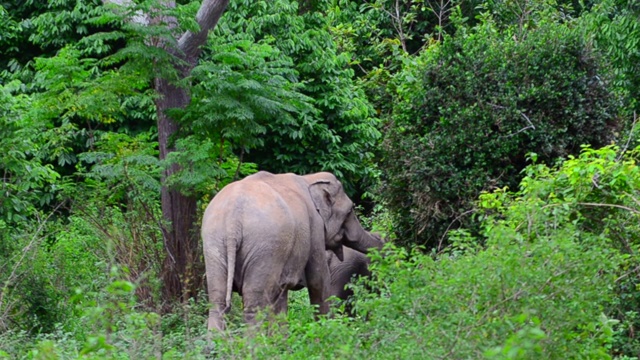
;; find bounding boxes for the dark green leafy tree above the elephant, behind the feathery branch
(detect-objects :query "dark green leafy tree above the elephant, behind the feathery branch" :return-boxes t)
[210,1,380,192]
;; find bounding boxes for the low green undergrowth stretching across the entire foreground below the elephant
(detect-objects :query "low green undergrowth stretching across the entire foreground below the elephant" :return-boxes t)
[0,147,640,359]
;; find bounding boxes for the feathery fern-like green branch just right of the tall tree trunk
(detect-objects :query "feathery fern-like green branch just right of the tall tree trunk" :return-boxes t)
[186,39,312,152]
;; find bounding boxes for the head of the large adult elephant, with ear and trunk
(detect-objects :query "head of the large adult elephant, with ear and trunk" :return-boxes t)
[305,172,383,261]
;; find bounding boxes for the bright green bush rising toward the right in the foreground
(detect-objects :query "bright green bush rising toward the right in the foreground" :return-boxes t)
[204,147,640,359]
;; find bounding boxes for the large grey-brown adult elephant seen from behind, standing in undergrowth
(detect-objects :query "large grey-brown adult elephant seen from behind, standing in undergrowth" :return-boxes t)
[201,171,382,330]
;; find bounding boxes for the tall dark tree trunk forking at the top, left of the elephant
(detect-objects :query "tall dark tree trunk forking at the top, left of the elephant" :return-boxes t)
[104,0,229,300]
